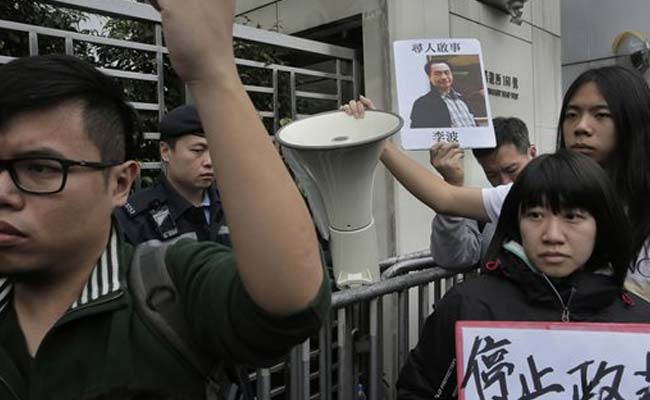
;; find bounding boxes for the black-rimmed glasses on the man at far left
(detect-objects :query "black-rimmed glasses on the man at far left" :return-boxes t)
[0,156,121,194]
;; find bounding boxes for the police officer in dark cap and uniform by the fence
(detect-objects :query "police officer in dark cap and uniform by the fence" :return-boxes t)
[115,105,230,245]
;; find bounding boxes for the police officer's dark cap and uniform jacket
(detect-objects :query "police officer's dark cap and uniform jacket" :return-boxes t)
[115,105,231,246]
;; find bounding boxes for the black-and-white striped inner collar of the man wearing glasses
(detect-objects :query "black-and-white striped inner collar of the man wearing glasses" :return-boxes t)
[0,227,123,312]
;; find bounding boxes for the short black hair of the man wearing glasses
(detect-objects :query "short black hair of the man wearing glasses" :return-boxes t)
[0,54,139,161]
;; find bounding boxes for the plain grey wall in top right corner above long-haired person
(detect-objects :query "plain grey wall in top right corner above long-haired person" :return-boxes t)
[562,0,650,89]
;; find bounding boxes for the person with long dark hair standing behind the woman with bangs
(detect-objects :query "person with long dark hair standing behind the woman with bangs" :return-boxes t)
[558,66,650,299]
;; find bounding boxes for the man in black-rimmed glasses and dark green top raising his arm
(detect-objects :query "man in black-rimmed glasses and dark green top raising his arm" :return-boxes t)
[0,0,330,400]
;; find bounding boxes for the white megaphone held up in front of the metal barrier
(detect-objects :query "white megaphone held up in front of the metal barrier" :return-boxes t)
[276,110,403,287]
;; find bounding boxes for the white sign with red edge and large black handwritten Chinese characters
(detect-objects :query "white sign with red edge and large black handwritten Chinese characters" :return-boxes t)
[456,321,650,400]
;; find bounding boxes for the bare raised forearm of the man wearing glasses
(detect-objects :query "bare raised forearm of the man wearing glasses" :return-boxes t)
[152,0,324,315]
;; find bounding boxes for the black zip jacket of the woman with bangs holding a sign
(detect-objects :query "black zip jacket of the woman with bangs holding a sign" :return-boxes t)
[397,248,650,400]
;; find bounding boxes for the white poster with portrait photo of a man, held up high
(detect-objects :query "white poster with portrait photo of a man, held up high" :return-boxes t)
[393,39,496,150]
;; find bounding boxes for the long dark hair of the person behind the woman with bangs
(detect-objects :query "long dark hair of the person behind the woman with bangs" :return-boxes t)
[558,66,650,260]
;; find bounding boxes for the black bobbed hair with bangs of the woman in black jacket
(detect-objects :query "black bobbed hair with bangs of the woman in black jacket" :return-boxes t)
[487,150,631,285]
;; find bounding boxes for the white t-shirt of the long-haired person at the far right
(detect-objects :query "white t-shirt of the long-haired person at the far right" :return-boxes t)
[481,183,650,301]
